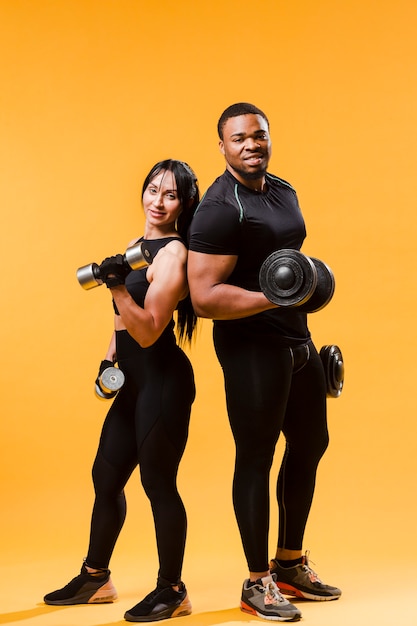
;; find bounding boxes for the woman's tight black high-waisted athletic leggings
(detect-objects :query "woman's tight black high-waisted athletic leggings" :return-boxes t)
[86,331,195,584]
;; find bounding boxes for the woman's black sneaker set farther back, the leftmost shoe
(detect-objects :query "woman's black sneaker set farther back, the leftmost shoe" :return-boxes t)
[43,563,117,605]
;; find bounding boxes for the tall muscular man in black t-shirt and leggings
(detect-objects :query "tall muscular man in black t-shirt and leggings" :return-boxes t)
[188,103,341,621]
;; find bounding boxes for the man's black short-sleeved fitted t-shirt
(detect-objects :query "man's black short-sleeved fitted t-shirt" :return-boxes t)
[189,170,310,344]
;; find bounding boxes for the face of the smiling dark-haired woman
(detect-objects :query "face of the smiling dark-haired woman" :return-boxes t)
[142,170,182,227]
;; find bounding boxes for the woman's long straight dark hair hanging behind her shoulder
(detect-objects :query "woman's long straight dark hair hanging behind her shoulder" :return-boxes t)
[142,159,200,343]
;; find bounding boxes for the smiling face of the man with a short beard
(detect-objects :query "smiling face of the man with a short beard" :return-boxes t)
[219,114,271,187]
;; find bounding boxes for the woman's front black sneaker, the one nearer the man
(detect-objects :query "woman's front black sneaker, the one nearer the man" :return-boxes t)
[125,578,191,622]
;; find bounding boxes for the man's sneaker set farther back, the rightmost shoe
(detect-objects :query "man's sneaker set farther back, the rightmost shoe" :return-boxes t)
[270,552,342,601]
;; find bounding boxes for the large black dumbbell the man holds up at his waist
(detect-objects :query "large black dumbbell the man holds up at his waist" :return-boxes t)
[259,248,335,313]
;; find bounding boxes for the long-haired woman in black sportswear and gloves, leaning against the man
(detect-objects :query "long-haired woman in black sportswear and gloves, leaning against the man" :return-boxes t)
[44,160,199,622]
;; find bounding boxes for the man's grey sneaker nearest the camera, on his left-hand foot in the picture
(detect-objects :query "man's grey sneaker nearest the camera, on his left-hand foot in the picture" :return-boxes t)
[240,575,301,622]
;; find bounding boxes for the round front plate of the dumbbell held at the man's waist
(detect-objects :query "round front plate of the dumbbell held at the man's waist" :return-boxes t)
[259,248,317,307]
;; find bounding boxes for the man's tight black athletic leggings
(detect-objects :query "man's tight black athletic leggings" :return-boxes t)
[214,326,328,572]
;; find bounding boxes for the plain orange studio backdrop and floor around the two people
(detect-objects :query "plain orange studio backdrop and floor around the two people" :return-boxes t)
[0,0,417,626]
